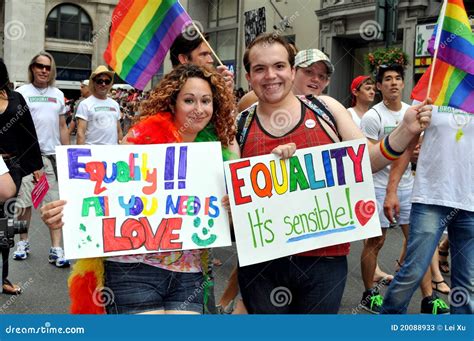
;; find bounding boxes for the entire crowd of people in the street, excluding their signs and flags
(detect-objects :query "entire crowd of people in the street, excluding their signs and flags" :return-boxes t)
[0,29,474,314]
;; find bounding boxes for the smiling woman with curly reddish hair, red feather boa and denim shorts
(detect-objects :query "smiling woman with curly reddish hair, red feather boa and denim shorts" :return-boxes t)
[42,65,240,314]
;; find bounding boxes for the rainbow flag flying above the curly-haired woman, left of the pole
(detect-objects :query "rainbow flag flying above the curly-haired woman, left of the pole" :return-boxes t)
[104,0,192,89]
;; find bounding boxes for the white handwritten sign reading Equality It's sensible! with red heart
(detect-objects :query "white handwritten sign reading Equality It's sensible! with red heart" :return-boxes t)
[225,139,381,266]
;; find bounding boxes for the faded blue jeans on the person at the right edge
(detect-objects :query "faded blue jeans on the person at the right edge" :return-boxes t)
[382,203,474,314]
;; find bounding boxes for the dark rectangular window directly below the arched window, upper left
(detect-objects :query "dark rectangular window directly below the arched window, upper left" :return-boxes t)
[49,51,92,81]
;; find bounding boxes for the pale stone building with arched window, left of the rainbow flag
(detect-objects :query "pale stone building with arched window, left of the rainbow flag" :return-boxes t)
[0,0,118,92]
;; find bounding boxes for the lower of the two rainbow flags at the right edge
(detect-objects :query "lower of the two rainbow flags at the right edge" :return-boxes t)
[411,59,474,113]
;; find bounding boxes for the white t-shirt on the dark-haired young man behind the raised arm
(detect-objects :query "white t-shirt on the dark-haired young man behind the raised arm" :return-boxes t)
[360,102,413,189]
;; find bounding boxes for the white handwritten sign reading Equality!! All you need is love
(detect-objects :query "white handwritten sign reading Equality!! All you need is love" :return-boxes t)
[56,142,231,259]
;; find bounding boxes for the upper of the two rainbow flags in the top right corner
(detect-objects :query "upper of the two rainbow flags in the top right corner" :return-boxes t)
[428,0,474,75]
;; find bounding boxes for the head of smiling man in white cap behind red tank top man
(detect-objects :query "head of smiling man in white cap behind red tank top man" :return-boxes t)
[293,49,334,96]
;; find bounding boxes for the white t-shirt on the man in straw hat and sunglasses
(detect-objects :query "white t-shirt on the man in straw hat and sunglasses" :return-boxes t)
[76,96,120,144]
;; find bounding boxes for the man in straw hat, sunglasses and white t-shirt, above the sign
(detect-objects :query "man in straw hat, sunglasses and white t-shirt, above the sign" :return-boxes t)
[76,65,122,145]
